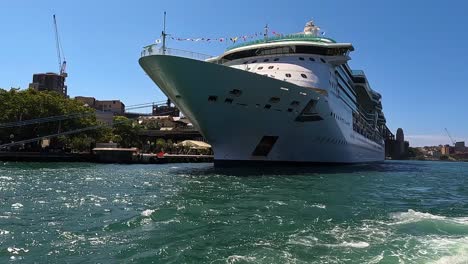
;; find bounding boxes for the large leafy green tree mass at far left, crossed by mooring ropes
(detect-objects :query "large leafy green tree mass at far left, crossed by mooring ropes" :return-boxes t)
[0,88,97,148]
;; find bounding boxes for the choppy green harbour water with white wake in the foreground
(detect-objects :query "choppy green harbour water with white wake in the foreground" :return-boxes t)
[0,162,468,263]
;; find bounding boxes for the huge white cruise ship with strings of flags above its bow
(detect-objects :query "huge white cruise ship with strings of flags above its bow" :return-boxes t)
[139,21,388,166]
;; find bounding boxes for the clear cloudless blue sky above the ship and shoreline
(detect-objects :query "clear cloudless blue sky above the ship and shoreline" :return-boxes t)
[0,0,468,146]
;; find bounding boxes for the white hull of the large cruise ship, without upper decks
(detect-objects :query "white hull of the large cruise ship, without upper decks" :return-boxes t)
[139,55,385,164]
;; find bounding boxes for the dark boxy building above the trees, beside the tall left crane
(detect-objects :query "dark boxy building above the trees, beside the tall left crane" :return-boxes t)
[29,72,67,96]
